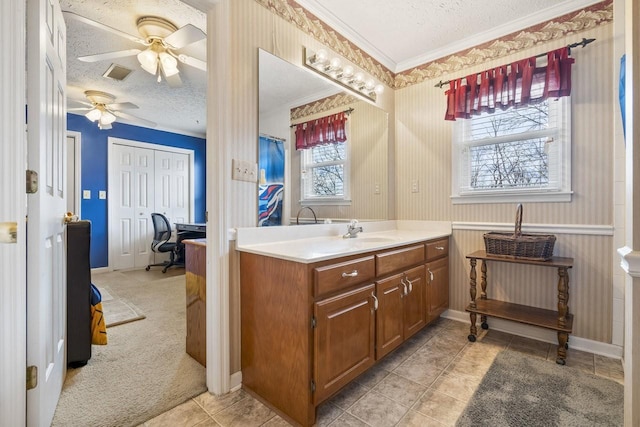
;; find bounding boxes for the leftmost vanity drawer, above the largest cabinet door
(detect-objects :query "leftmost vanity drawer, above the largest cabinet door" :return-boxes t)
[313,256,376,296]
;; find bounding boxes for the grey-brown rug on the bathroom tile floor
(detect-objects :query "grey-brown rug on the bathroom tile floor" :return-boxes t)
[456,350,624,427]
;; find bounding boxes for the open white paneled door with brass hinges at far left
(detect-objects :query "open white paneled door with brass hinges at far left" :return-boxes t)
[27,0,67,426]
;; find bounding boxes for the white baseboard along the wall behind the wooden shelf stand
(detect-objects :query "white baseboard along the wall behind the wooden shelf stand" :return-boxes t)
[442,310,623,359]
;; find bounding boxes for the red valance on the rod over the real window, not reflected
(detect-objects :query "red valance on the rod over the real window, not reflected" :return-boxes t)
[444,46,574,120]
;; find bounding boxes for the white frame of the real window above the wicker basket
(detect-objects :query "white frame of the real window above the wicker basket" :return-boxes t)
[451,96,573,204]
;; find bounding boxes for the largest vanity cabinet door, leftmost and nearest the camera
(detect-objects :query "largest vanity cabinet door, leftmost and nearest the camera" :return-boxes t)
[313,284,375,404]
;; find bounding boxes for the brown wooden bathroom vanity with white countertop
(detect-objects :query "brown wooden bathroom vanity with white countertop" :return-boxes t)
[237,221,451,426]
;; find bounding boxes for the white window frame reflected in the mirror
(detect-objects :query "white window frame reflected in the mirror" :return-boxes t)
[300,141,351,206]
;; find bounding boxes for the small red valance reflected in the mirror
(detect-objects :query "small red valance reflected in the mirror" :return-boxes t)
[296,112,347,150]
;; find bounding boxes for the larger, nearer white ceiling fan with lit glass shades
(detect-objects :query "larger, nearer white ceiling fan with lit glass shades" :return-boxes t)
[63,11,207,87]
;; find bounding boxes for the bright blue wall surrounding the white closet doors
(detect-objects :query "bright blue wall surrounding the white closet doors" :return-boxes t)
[67,114,206,268]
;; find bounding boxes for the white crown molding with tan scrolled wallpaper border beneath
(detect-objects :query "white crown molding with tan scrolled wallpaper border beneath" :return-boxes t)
[255,0,613,89]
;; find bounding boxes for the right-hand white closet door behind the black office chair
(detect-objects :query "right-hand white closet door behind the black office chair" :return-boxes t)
[155,150,190,228]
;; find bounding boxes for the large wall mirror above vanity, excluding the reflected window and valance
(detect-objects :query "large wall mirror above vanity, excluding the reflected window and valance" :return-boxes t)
[258,49,389,226]
